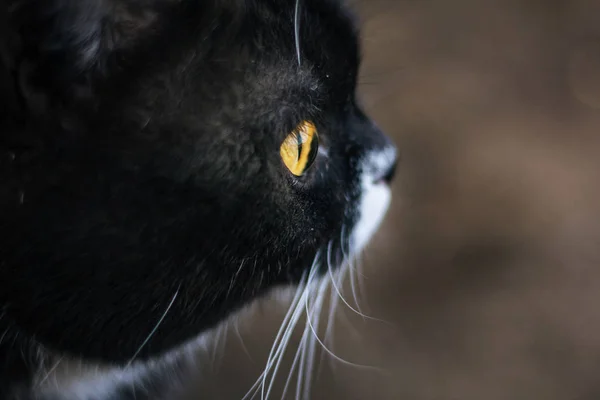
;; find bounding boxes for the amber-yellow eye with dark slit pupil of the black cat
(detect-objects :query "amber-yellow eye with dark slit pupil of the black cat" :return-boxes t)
[279,121,319,176]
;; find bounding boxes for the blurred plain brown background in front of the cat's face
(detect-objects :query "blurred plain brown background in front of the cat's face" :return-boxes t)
[198,0,600,400]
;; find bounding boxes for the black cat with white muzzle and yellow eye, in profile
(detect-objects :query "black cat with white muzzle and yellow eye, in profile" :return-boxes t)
[0,0,397,400]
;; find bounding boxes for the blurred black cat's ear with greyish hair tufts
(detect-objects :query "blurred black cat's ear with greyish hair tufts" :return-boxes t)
[5,0,166,108]
